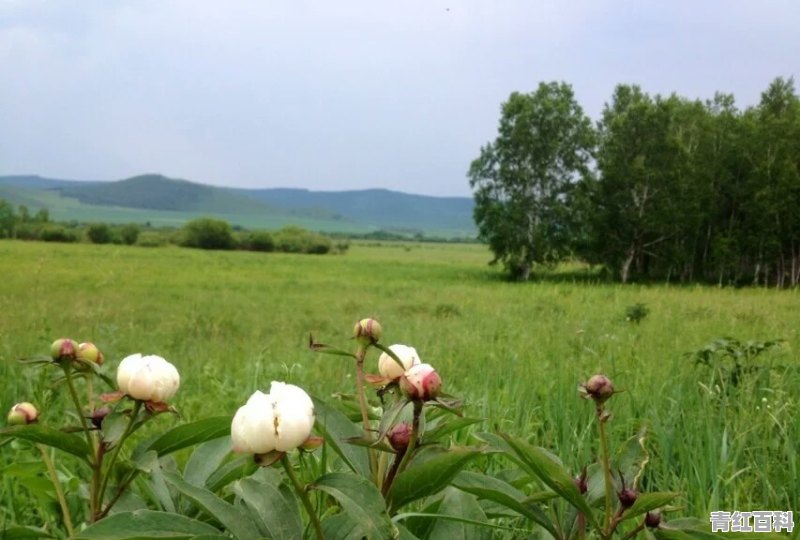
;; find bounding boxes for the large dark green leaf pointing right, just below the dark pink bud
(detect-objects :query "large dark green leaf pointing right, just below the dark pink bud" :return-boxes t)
[389,448,481,509]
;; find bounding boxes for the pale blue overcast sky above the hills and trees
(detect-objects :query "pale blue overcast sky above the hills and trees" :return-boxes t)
[0,0,800,196]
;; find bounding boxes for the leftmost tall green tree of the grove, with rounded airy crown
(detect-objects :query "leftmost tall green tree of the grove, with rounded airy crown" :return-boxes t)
[468,82,594,280]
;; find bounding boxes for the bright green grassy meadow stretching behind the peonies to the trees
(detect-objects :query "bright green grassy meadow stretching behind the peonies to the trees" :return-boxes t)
[0,241,800,517]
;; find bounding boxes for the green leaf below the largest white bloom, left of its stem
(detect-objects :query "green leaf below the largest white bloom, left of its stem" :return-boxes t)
[232,478,303,540]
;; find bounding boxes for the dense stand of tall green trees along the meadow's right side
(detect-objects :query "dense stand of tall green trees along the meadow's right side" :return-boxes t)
[468,78,800,287]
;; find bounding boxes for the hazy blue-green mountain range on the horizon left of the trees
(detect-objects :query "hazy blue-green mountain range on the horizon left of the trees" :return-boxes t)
[0,174,476,238]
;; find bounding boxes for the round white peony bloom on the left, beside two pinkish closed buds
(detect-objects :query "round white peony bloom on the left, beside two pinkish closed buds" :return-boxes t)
[117,353,181,403]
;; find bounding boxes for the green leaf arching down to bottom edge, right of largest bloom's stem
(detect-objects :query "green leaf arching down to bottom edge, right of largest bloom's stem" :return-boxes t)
[310,473,396,539]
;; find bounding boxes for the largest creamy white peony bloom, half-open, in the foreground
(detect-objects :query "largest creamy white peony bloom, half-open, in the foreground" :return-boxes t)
[231,381,315,454]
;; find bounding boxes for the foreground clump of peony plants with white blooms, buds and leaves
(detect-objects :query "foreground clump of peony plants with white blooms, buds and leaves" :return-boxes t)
[0,319,776,540]
